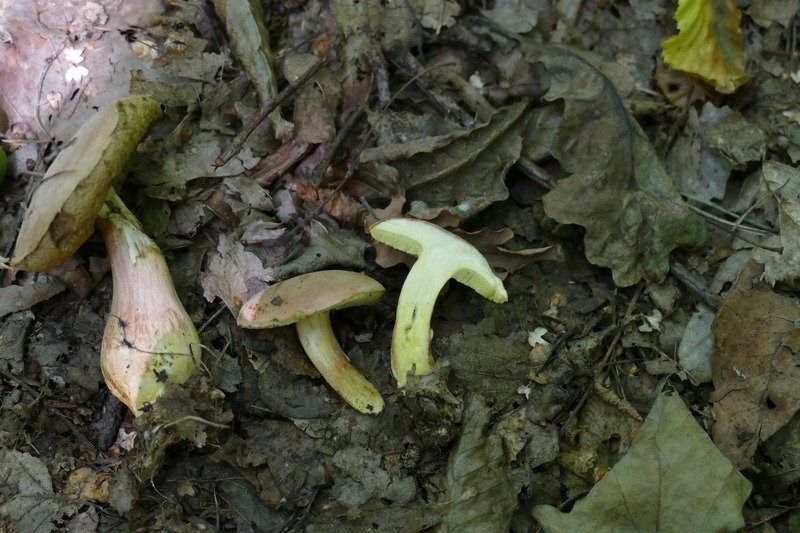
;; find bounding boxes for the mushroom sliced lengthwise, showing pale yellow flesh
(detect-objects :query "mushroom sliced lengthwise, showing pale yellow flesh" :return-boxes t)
[369,218,508,388]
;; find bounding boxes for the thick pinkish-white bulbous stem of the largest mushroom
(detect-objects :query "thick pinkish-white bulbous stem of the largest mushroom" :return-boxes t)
[97,189,200,414]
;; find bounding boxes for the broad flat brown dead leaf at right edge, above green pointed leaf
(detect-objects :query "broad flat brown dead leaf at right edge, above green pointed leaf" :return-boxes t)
[712,261,800,468]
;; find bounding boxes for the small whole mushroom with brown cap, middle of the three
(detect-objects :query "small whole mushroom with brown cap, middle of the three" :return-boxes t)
[238,270,385,414]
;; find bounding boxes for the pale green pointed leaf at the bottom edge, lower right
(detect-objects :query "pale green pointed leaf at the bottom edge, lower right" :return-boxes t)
[533,395,751,533]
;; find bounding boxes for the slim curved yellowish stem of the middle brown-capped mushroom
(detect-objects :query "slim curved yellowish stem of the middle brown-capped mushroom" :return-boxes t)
[295,311,383,415]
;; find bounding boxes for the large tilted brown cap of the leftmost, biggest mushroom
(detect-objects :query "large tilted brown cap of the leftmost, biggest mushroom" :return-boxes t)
[11,96,161,272]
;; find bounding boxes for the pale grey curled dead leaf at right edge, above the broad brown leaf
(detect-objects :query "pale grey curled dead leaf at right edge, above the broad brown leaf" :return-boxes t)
[753,161,800,285]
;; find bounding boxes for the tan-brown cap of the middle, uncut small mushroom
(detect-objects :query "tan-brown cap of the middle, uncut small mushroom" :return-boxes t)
[237,270,386,329]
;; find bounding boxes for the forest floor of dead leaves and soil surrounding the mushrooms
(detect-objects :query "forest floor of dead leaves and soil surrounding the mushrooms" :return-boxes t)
[0,0,800,533]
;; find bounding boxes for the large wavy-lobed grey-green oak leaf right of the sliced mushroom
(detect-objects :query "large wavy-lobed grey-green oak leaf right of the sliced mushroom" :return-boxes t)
[523,41,705,287]
